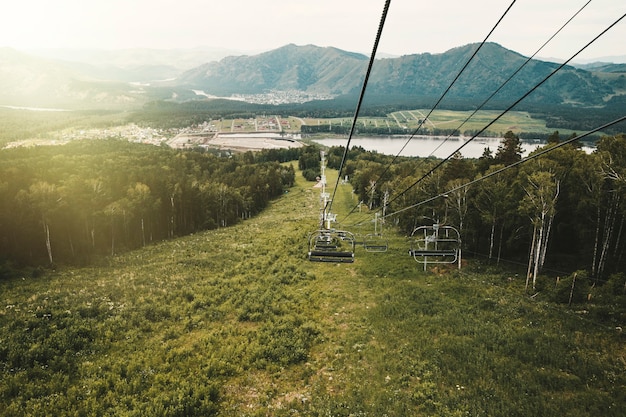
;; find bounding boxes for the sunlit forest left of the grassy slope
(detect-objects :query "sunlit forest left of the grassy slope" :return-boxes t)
[0,139,295,271]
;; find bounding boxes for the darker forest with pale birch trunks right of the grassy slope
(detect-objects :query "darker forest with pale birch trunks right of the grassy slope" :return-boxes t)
[336,131,626,287]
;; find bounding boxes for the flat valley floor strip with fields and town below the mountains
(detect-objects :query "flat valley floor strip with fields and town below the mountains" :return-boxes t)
[0,109,571,148]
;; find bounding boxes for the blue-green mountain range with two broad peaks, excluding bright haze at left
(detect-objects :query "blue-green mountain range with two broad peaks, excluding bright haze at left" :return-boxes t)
[175,43,614,106]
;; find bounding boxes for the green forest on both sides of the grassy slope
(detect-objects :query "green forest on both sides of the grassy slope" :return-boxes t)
[0,128,626,283]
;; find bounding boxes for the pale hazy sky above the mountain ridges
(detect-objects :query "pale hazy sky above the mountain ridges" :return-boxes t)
[0,0,626,60]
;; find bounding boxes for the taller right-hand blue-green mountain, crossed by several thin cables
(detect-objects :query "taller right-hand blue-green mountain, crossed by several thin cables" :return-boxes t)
[368,43,614,106]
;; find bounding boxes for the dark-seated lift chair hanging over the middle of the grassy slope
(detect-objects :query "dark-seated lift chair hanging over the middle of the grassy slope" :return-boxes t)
[308,229,355,263]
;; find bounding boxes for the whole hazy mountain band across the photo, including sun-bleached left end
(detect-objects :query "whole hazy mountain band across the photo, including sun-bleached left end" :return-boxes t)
[0,43,626,108]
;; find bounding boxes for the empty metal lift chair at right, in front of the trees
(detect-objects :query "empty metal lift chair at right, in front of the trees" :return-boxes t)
[409,223,461,270]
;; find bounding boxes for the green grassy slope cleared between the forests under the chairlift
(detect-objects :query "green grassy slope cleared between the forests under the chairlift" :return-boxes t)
[0,167,626,416]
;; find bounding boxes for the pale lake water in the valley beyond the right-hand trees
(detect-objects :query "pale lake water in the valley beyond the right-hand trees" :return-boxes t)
[314,136,545,158]
